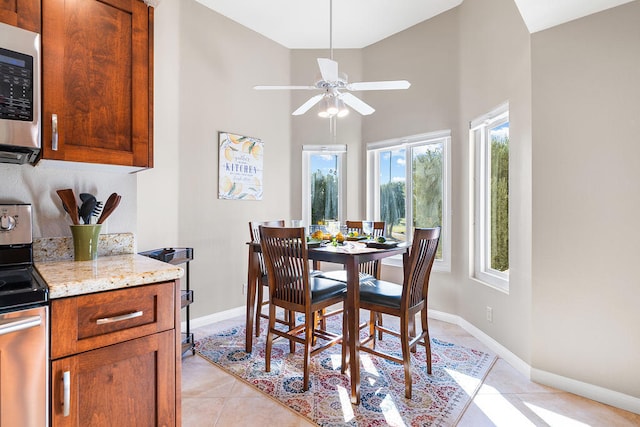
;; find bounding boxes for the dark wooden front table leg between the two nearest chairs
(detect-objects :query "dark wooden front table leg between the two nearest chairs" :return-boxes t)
[345,256,360,405]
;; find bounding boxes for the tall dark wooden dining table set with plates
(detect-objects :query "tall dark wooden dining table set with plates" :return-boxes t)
[245,241,411,405]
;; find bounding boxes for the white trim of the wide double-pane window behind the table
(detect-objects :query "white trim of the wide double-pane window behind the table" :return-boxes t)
[367,130,452,272]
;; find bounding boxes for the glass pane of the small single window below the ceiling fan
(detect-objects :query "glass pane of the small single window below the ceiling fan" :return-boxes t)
[311,154,339,224]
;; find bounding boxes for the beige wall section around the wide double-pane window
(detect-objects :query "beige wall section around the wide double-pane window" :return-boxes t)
[361,9,464,313]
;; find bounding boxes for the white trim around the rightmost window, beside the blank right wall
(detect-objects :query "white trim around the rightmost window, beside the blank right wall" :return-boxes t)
[469,102,509,294]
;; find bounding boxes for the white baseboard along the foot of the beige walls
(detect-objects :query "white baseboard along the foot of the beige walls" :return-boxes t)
[188,306,640,414]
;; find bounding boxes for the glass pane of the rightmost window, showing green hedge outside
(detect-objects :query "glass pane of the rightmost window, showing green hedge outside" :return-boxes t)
[489,122,509,271]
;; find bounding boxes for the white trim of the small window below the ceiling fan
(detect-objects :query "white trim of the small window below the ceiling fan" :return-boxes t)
[302,144,347,229]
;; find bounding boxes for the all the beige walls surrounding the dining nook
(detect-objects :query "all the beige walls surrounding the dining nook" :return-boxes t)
[144,0,640,405]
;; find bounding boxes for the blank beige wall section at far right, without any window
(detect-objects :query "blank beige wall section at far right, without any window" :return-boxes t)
[532,1,640,397]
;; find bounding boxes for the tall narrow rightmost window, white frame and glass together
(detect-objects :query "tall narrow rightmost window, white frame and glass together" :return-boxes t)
[470,104,509,292]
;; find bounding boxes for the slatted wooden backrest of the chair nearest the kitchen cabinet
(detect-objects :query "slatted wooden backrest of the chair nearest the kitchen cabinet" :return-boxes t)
[259,226,311,311]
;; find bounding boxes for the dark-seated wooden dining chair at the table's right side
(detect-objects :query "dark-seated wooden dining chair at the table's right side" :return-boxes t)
[360,227,440,399]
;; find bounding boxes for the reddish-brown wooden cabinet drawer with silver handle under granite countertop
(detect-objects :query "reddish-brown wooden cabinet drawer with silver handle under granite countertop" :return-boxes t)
[51,282,176,359]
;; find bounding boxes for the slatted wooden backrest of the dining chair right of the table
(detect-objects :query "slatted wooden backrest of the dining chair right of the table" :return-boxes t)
[400,227,440,309]
